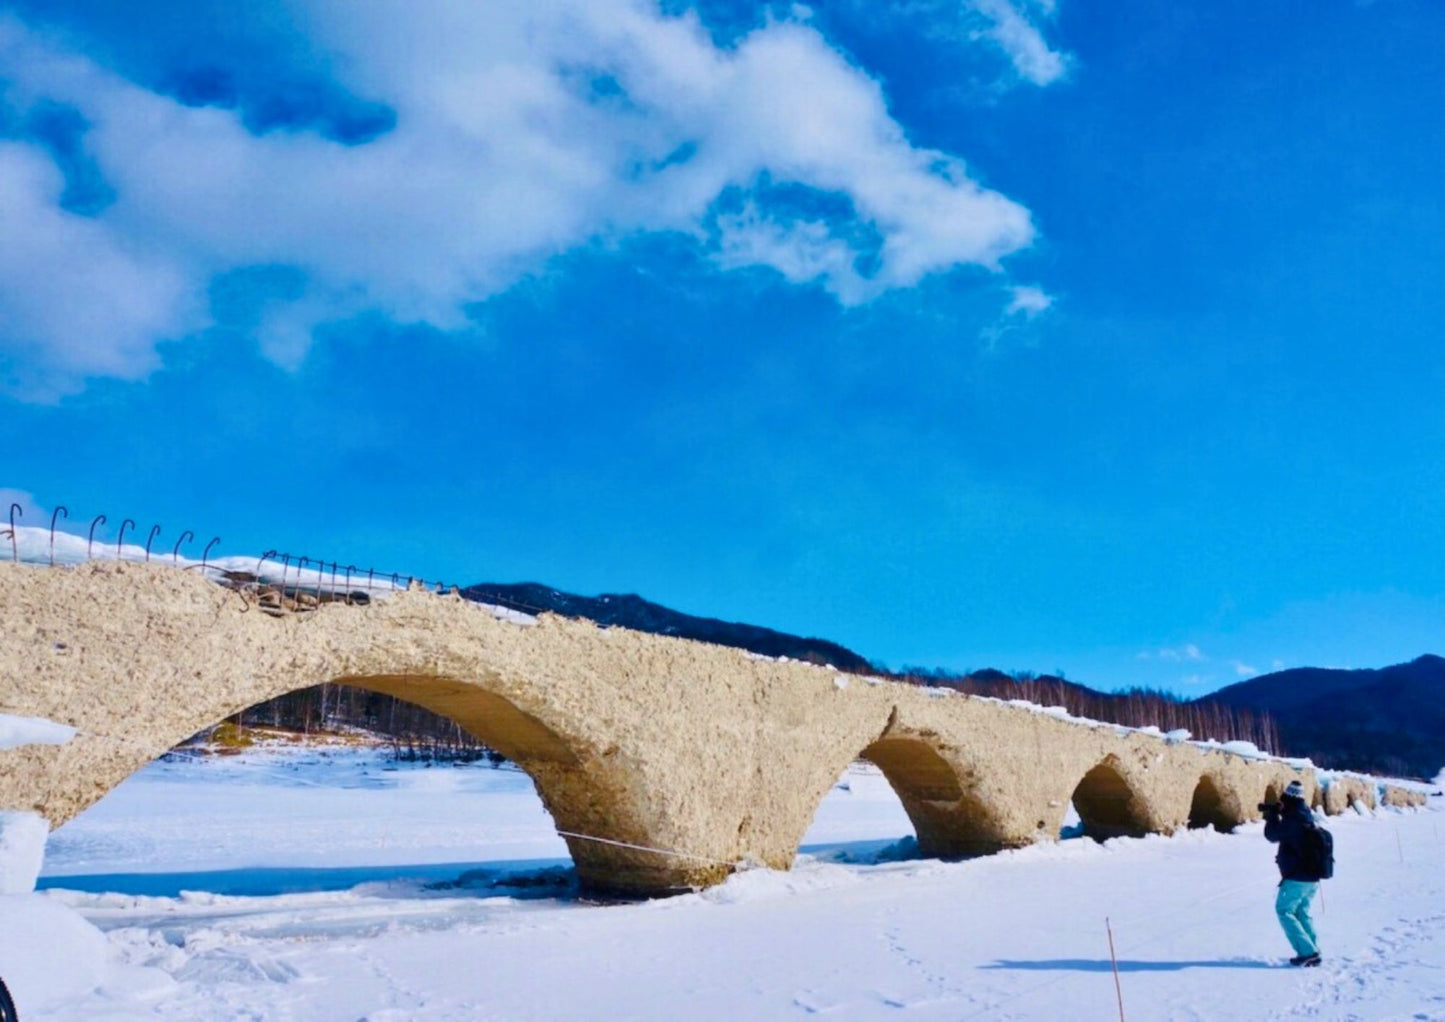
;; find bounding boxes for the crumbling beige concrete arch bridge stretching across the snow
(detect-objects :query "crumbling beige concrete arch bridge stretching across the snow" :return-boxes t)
[0,562,1409,893]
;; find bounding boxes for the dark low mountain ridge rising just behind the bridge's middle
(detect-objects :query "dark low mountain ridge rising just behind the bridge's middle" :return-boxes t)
[461,583,871,671]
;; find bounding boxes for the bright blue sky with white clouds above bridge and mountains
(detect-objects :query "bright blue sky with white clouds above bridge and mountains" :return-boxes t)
[0,0,1445,694]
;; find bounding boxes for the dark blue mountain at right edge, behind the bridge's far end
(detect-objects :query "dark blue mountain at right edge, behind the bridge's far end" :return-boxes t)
[1205,653,1445,778]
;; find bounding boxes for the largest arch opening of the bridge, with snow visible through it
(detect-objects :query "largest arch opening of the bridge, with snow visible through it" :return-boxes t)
[45,678,579,895]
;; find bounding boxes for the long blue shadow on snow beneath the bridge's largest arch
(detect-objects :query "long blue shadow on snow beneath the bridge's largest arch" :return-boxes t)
[36,859,578,901]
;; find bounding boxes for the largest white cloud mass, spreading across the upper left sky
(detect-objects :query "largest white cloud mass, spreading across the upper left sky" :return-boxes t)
[0,0,1042,389]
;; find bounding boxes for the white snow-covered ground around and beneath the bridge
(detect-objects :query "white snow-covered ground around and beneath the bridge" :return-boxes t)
[0,750,1445,1022]
